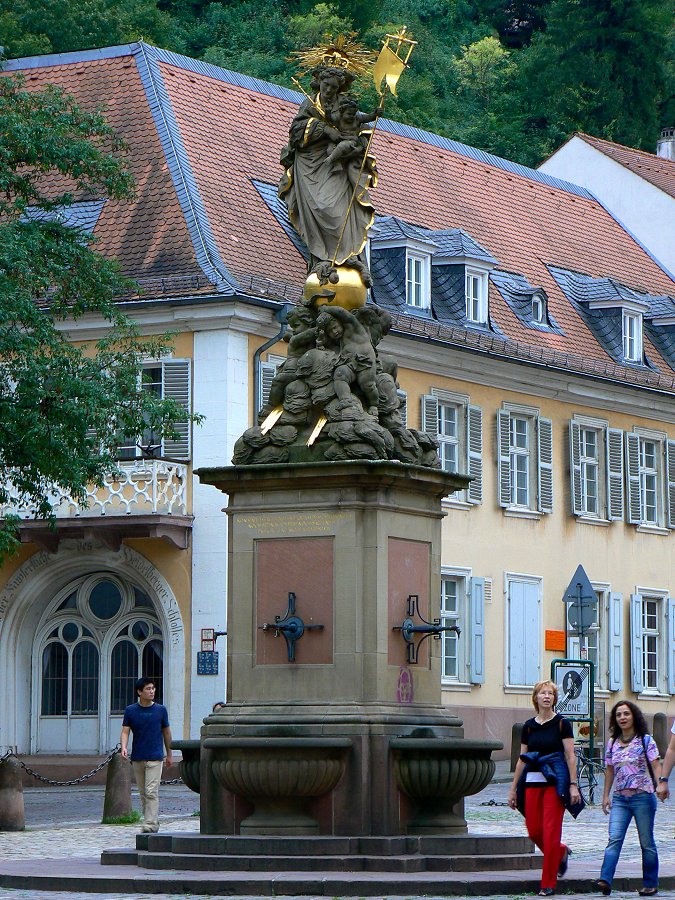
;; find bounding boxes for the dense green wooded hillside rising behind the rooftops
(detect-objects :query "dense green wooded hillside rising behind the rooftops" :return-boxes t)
[0,0,675,165]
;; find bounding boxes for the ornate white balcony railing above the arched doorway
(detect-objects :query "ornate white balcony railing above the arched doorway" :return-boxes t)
[0,459,187,519]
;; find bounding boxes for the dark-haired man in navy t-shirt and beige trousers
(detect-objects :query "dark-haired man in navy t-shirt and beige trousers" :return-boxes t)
[120,678,172,832]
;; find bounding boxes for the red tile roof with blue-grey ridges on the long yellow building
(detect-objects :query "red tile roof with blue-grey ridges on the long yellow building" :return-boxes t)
[5,45,675,388]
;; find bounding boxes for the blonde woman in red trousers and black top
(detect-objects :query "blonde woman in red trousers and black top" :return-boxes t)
[509,681,581,897]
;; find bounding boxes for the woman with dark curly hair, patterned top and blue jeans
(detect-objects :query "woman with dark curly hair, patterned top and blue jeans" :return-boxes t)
[595,700,661,897]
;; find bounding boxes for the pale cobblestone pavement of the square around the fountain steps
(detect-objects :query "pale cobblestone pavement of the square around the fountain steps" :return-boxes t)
[0,784,675,900]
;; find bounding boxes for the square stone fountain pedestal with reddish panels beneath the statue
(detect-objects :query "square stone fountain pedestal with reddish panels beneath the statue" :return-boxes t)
[198,462,500,835]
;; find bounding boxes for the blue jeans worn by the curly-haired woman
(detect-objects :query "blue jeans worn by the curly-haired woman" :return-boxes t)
[600,791,659,887]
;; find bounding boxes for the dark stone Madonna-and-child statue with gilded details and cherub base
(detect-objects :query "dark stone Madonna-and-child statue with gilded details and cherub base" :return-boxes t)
[234,30,440,467]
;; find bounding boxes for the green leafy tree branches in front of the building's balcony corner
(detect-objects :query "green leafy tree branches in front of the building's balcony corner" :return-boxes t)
[0,76,199,556]
